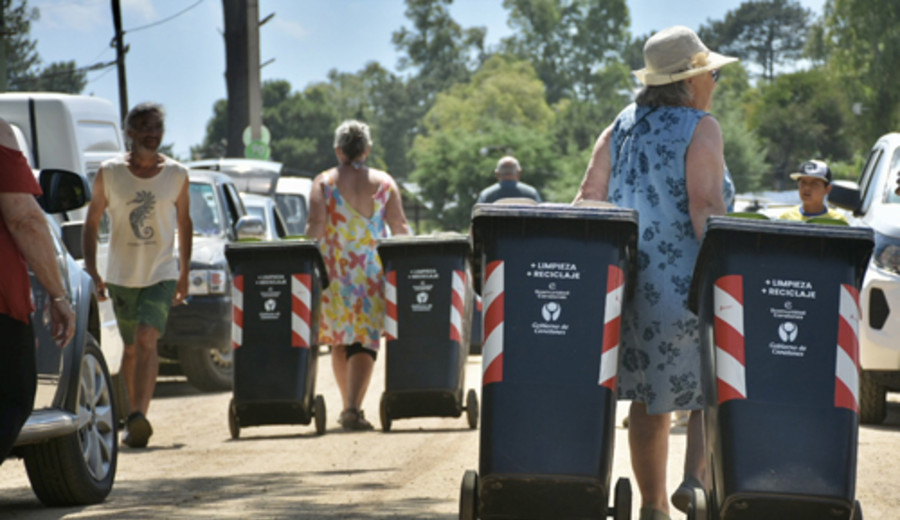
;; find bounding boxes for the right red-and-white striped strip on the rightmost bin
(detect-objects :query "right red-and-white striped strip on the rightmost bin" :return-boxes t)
[834,284,861,413]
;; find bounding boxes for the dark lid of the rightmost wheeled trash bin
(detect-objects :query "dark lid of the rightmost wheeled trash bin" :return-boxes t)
[688,216,875,313]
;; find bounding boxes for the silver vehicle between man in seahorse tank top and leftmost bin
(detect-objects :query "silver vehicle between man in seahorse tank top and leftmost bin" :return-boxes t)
[159,170,265,391]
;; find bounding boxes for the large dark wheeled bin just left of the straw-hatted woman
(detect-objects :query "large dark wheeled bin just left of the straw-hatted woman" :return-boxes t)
[460,203,638,520]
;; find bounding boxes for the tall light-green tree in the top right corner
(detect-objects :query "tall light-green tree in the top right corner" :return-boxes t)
[825,0,900,147]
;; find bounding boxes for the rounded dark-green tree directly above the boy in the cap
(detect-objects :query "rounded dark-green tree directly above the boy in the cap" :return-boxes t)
[749,69,852,187]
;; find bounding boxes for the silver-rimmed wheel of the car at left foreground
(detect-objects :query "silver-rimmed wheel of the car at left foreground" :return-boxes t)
[24,334,119,506]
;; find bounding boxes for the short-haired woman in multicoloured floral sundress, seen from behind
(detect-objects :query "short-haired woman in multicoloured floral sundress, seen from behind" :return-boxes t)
[306,120,410,430]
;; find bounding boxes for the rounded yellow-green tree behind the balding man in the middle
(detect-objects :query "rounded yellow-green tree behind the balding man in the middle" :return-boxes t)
[411,55,557,230]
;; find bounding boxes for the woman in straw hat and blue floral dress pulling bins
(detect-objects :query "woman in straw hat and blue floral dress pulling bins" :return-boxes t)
[575,26,737,520]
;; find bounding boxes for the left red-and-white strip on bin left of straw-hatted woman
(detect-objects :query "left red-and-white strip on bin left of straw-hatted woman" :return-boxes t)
[481,260,505,386]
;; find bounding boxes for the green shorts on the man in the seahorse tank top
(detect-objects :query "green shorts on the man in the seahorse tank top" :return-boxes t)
[106,280,175,345]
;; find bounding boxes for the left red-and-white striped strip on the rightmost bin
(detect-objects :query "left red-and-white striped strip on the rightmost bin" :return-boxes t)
[713,275,747,404]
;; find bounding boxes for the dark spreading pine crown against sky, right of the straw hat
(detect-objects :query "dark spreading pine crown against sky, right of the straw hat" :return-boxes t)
[698,0,812,81]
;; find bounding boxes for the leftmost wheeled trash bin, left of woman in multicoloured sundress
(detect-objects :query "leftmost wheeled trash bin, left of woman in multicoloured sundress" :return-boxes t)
[225,240,328,439]
